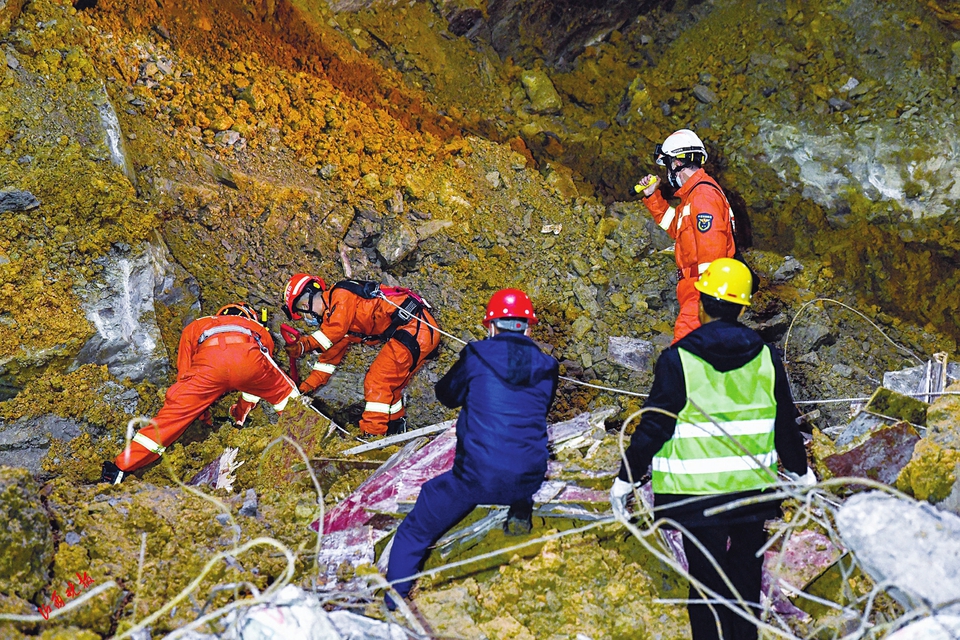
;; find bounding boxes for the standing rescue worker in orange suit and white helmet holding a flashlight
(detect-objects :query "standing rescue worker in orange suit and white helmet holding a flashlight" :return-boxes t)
[636,129,736,342]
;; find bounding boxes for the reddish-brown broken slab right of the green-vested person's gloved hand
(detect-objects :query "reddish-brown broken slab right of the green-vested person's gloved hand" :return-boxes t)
[822,422,920,486]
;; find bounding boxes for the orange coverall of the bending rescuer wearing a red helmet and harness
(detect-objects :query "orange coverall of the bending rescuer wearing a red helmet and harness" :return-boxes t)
[300,286,440,435]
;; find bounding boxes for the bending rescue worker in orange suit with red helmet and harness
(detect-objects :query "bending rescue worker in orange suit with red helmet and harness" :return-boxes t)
[283,273,440,435]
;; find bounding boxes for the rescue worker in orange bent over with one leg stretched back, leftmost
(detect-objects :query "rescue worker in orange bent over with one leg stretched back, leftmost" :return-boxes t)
[101,302,300,484]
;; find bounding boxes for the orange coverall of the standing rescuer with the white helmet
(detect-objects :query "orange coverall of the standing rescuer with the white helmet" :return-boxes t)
[643,169,736,342]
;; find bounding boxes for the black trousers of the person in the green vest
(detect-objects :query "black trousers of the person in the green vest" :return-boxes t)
[683,521,767,640]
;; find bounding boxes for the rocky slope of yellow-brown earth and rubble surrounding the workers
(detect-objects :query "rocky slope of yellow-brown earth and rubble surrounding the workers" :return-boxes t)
[0,0,960,638]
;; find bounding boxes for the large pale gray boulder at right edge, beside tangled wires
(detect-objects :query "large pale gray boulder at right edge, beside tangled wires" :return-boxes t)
[837,492,960,615]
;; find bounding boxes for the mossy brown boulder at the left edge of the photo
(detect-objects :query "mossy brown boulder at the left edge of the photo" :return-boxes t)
[0,467,53,600]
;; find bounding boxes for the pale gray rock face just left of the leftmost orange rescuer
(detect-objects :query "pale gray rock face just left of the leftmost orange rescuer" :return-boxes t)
[73,239,199,383]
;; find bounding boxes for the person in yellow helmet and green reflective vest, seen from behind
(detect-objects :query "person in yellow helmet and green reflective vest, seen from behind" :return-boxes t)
[610,258,816,640]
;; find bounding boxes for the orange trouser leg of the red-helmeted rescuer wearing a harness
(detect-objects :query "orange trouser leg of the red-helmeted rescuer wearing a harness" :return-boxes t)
[360,312,440,435]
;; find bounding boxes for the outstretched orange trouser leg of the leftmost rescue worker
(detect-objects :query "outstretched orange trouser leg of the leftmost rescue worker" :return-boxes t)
[114,369,230,472]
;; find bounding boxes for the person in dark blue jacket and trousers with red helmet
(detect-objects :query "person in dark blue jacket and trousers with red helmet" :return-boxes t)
[386,289,558,609]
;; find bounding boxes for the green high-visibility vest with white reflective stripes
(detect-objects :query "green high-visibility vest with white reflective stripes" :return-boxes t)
[653,346,777,495]
